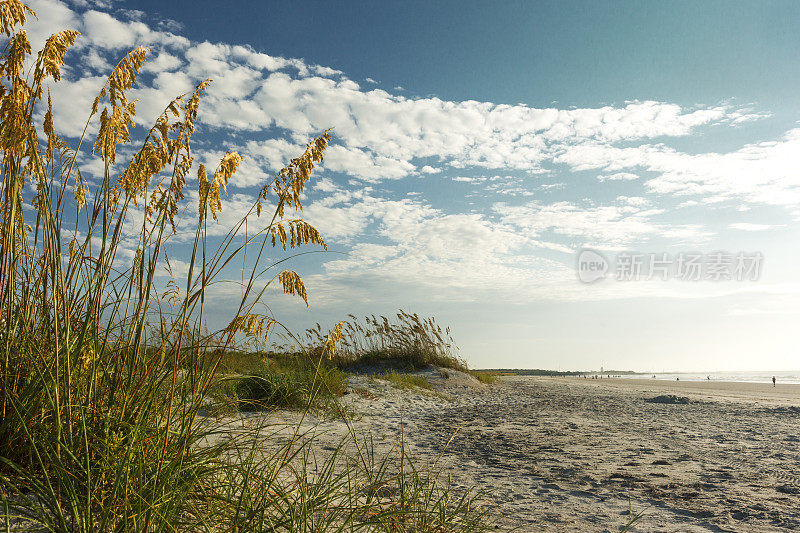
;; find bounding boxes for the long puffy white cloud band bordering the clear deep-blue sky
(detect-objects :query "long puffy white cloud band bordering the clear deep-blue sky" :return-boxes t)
[37,0,758,194]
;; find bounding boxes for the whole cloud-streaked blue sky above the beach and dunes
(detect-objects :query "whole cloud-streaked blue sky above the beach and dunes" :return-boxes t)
[32,0,800,371]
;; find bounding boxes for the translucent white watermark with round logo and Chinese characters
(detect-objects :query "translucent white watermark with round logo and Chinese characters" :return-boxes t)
[577,249,764,283]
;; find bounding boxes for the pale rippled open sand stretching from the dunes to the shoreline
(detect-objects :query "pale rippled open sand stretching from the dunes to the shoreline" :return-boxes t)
[211,371,800,531]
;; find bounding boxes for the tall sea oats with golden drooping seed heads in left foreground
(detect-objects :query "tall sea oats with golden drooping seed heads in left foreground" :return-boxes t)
[0,0,330,531]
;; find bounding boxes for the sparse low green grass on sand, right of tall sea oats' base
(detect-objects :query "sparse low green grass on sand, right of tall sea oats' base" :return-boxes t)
[193,420,493,533]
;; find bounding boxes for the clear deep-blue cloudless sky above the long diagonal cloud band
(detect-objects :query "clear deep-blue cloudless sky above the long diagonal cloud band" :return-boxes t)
[129,0,800,109]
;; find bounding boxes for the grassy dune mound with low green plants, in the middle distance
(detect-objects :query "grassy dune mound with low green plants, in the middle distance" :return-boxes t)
[203,310,499,411]
